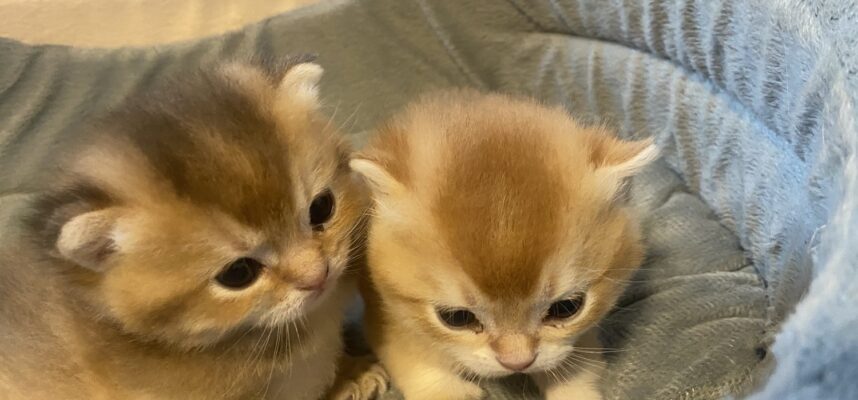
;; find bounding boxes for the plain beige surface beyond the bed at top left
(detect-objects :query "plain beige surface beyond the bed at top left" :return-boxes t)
[0,0,319,47]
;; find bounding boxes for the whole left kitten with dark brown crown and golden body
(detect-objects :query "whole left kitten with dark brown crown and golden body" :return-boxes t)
[0,58,365,399]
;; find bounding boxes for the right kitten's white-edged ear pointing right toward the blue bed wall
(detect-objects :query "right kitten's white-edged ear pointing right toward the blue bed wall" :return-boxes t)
[590,134,659,200]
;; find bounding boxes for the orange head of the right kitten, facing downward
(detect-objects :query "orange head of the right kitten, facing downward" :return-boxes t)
[351,92,657,376]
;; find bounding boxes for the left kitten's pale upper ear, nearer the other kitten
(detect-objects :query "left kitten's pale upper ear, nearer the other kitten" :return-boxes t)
[277,62,324,111]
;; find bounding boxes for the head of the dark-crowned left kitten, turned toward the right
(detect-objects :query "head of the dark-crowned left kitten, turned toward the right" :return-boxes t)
[33,60,362,348]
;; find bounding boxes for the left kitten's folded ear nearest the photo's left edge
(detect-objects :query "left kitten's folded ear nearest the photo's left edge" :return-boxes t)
[56,208,118,272]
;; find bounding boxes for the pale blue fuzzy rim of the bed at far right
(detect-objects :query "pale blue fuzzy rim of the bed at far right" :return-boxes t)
[750,1,858,400]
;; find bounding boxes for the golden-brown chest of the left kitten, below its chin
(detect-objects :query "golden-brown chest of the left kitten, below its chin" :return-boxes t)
[89,290,342,400]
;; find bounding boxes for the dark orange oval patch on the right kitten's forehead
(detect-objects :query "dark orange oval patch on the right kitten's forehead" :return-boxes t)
[433,109,568,298]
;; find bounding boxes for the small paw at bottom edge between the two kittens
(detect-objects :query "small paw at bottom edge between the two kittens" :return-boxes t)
[328,358,390,400]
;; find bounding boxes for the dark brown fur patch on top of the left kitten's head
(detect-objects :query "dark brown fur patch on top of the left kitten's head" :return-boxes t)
[87,62,338,236]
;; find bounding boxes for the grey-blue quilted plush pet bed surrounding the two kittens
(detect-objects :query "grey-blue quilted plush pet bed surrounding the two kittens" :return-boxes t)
[0,0,858,399]
